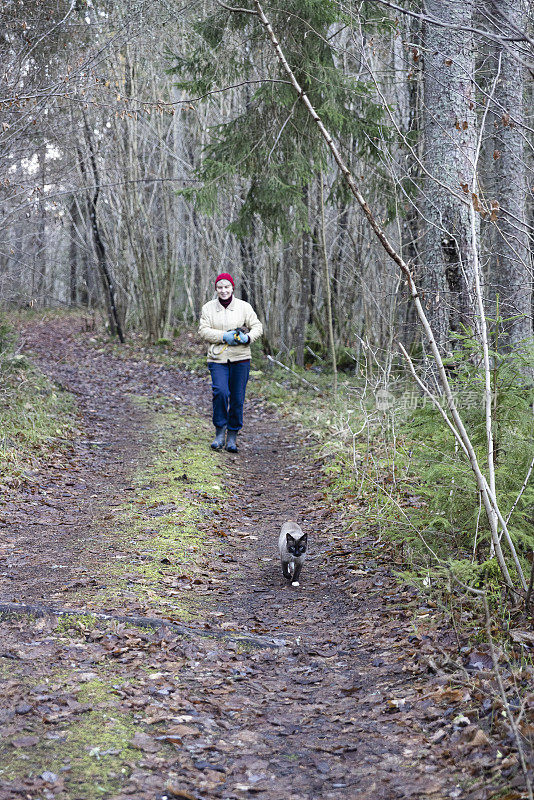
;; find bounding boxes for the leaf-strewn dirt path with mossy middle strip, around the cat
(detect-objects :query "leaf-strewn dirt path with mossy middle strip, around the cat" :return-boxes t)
[0,318,523,800]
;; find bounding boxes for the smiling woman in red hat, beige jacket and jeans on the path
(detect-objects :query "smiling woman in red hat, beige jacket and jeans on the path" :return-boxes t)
[198,272,263,453]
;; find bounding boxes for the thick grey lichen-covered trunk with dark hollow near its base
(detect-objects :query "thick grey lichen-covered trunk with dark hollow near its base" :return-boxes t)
[426,0,476,351]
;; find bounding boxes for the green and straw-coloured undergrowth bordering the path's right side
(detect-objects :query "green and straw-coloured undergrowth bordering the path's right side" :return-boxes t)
[155,322,534,613]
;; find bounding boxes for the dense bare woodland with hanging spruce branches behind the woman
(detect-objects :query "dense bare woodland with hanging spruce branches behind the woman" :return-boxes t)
[0,0,533,356]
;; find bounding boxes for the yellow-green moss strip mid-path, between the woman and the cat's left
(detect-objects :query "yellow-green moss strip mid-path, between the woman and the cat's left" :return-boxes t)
[74,397,225,620]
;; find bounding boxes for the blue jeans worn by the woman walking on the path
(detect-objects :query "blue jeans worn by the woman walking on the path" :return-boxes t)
[208,361,250,431]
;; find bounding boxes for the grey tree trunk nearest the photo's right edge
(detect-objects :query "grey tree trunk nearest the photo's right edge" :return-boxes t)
[492,0,532,349]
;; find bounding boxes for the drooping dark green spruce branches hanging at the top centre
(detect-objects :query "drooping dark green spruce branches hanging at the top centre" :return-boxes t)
[170,0,387,238]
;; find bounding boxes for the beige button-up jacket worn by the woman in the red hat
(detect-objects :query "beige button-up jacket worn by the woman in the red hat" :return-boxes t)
[198,297,263,364]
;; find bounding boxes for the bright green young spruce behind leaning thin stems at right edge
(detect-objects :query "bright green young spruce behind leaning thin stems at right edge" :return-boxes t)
[401,336,534,557]
